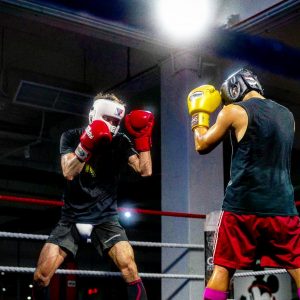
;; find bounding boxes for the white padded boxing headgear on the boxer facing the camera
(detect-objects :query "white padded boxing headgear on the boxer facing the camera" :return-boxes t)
[89,99,125,135]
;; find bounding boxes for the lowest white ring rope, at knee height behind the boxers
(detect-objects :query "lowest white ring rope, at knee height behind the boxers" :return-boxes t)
[0,266,204,280]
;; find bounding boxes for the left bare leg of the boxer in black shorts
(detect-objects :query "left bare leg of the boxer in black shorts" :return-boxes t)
[33,243,67,300]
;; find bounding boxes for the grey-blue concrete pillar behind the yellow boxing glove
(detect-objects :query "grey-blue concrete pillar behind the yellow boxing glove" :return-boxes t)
[161,52,224,300]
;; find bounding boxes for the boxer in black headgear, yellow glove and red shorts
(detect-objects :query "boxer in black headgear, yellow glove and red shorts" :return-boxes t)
[188,68,300,300]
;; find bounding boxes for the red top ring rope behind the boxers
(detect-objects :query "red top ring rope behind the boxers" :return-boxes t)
[0,195,206,219]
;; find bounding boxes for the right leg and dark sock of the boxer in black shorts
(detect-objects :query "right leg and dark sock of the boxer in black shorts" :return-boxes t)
[108,241,147,300]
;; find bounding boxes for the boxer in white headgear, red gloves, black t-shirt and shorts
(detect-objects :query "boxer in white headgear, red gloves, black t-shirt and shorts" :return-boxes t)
[33,93,153,300]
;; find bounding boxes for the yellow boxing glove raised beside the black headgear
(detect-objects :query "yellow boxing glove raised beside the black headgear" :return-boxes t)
[187,84,221,130]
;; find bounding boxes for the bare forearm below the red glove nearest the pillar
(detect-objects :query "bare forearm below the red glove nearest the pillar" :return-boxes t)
[128,151,152,177]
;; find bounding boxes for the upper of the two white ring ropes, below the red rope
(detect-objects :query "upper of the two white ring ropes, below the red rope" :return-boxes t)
[0,231,204,250]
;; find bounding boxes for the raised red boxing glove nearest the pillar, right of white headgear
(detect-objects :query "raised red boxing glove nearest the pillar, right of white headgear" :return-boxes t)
[125,110,154,152]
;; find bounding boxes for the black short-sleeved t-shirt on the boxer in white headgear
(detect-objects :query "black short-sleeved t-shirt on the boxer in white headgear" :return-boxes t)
[60,128,136,224]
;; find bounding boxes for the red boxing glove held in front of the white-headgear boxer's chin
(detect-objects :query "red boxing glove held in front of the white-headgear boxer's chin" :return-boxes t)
[75,120,112,162]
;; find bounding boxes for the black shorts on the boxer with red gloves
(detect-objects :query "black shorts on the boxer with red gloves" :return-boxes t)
[46,221,128,256]
